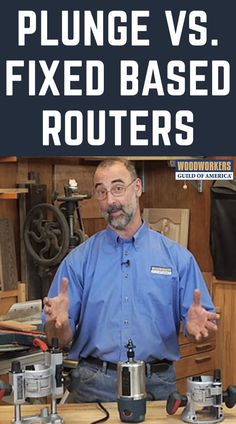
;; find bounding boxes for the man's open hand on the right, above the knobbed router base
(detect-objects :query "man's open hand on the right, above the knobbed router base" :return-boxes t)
[187,289,219,341]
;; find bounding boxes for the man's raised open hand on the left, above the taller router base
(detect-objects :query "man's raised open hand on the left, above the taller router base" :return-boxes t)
[43,277,69,329]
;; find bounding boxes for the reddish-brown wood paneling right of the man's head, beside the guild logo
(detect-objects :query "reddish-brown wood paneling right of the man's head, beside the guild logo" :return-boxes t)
[141,161,212,271]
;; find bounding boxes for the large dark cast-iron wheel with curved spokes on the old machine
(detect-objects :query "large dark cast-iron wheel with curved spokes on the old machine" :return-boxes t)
[24,203,69,266]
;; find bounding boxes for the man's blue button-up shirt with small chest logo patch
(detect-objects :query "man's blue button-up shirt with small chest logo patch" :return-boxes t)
[43,223,215,363]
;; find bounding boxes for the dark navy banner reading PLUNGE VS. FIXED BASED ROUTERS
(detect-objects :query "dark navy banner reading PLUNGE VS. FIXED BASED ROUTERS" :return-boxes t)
[0,0,236,156]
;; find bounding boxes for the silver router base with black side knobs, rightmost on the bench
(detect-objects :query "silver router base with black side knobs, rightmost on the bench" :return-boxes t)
[166,369,236,424]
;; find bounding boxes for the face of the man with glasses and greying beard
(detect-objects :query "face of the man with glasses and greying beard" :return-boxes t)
[94,163,141,230]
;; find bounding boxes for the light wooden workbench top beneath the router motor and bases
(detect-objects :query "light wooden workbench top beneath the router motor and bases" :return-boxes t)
[0,401,236,424]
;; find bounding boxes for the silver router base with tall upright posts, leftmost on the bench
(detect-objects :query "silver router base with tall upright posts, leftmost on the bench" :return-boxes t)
[0,338,64,424]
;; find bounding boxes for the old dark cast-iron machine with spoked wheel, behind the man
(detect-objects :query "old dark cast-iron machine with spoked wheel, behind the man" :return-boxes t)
[23,179,89,298]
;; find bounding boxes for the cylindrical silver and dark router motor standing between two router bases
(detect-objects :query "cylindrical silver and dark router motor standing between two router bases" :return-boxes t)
[117,339,146,422]
